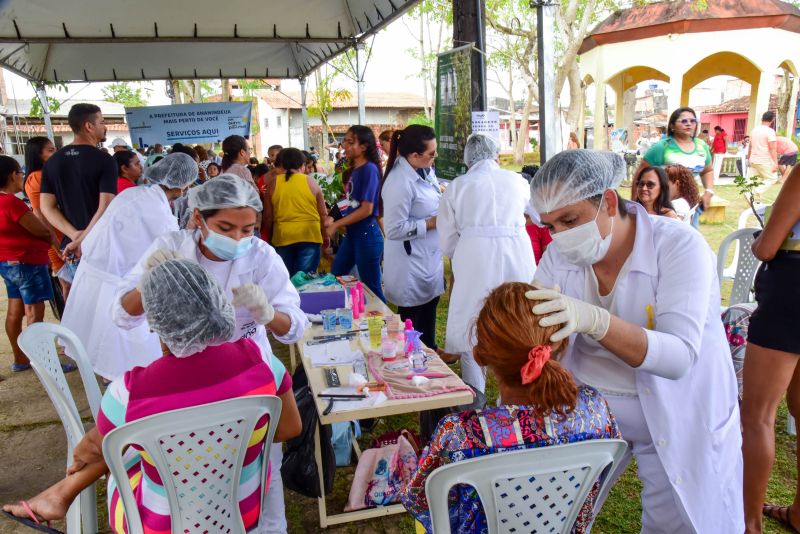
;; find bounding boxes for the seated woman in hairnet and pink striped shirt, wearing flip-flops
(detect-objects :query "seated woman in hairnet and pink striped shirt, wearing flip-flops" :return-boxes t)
[3,257,302,534]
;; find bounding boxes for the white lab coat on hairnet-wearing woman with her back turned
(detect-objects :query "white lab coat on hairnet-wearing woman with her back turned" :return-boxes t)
[436,160,536,353]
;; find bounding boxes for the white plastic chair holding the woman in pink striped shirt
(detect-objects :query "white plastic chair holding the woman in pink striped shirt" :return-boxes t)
[103,395,281,534]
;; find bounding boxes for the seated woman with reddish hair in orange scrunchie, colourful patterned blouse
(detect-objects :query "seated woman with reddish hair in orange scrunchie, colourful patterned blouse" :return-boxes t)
[401,282,620,533]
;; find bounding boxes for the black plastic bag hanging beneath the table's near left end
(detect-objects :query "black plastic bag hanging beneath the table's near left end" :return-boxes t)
[281,367,336,497]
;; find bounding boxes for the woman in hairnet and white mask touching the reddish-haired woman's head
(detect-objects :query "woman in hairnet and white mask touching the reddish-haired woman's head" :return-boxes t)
[527,150,744,533]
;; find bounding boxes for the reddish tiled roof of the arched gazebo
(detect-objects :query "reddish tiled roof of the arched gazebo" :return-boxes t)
[578,0,800,54]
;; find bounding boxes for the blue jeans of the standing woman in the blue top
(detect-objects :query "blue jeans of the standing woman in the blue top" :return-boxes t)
[331,218,386,302]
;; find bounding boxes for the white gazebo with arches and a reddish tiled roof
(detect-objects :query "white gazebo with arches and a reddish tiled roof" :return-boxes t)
[579,0,800,148]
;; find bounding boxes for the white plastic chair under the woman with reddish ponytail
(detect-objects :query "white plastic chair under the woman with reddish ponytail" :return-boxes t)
[425,439,628,534]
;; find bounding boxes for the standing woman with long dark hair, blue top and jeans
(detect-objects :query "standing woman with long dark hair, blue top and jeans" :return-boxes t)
[325,125,386,302]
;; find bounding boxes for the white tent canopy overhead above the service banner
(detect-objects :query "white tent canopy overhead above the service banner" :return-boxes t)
[0,0,418,82]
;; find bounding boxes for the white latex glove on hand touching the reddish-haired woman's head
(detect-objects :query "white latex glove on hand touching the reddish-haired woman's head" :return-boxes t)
[525,284,611,342]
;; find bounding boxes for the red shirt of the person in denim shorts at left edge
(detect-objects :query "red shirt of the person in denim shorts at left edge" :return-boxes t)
[0,193,50,265]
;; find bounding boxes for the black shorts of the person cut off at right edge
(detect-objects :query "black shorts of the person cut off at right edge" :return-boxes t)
[747,251,800,355]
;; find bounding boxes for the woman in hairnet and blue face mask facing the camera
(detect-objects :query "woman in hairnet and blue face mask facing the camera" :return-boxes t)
[114,174,307,533]
